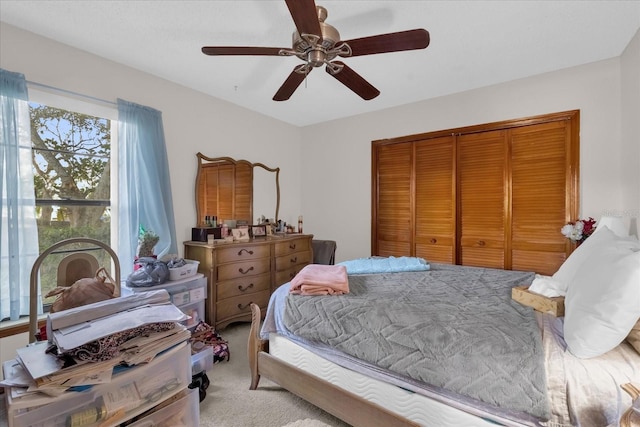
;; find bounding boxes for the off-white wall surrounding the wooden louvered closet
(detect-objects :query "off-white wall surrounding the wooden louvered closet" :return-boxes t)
[302,36,640,261]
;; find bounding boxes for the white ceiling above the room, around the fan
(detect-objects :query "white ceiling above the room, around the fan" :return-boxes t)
[0,0,640,126]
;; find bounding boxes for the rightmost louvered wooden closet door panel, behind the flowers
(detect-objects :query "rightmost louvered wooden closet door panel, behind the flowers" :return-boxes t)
[511,121,571,275]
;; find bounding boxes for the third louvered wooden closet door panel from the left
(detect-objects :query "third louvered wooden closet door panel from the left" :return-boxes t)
[458,131,508,268]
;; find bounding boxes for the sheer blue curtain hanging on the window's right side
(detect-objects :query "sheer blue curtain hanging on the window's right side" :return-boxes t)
[118,99,178,277]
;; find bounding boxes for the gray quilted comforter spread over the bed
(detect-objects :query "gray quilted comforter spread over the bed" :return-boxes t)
[283,264,550,419]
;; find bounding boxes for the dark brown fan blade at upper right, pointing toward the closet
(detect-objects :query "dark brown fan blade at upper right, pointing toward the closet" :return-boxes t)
[340,29,429,56]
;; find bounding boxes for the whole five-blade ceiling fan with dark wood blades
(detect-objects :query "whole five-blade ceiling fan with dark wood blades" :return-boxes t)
[202,0,429,101]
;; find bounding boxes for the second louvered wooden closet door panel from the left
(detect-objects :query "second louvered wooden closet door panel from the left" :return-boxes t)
[414,136,456,264]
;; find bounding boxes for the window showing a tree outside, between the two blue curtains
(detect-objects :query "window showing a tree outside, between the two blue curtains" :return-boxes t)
[0,87,117,320]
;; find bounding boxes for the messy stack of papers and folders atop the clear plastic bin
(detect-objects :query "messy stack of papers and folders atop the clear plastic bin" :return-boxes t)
[0,290,191,397]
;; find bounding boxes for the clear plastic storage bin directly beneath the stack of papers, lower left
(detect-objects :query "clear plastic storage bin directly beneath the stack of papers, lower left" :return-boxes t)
[7,342,192,427]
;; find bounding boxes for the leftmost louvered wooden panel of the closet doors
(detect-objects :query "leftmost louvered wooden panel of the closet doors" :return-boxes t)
[372,143,412,256]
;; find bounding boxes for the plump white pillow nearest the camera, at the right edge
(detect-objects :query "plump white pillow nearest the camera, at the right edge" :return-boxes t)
[564,246,640,359]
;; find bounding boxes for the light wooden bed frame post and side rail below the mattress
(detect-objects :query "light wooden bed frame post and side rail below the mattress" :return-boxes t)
[247,303,419,427]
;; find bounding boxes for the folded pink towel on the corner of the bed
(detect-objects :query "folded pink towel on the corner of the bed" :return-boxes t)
[289,264,349,295]
